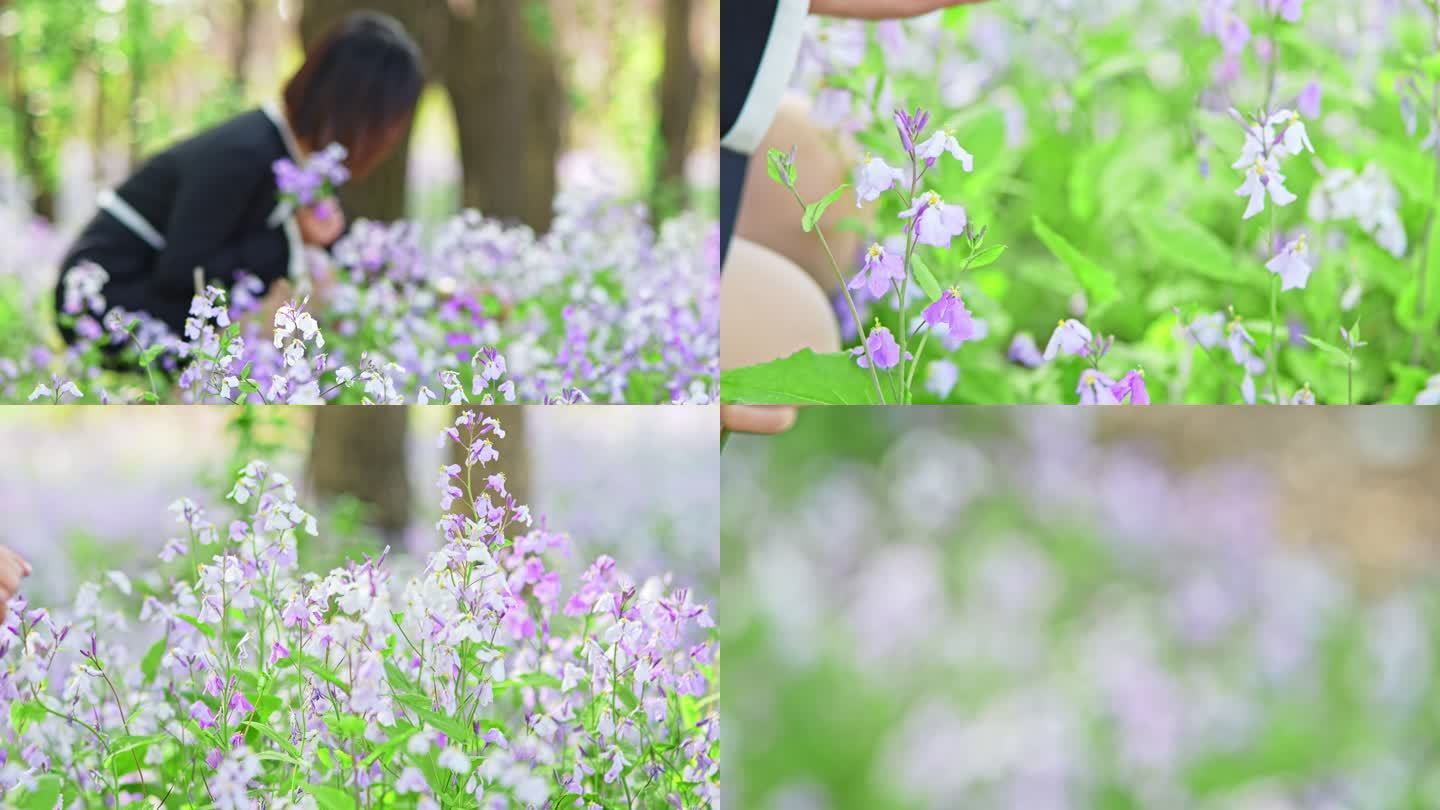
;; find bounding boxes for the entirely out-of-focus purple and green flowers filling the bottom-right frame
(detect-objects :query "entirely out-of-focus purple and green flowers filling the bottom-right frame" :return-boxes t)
[721,408,1440,810]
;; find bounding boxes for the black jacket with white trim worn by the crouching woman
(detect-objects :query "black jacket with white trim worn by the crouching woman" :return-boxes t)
[56,110,300,331]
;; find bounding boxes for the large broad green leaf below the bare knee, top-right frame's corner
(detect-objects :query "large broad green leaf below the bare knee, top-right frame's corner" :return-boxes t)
[720,349,883,405]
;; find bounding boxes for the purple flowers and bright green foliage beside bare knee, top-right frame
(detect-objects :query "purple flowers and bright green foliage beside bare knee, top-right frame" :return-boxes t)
[723,0,1440,405]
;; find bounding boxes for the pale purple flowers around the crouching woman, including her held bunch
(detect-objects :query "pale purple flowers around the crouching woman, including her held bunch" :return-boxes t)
[0,147,720,404]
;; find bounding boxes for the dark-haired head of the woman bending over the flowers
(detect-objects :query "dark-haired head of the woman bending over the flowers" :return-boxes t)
[285,12,425,177]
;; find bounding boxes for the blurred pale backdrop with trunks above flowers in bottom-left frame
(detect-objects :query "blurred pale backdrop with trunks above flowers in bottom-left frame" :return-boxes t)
[0,406,720,608]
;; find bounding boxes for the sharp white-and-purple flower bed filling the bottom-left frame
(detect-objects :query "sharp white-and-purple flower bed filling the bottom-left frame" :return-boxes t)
[0,411,720,810]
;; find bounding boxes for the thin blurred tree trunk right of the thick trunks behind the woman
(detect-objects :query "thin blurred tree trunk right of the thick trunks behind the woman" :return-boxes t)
[651,0,700,219]
